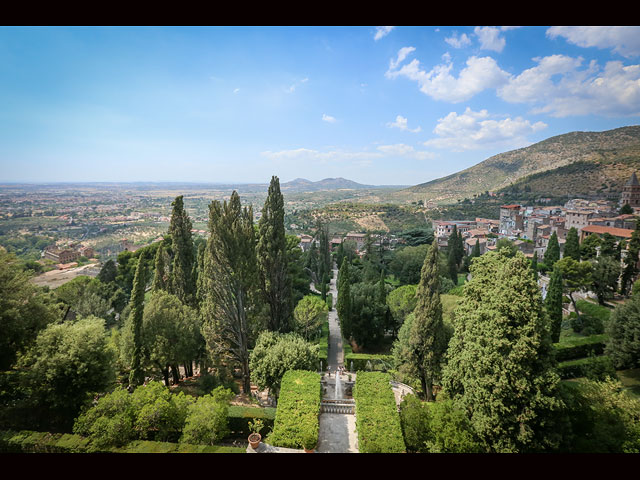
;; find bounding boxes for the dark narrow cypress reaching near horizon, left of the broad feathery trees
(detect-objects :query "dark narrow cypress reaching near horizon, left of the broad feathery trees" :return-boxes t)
[168,195,195,306]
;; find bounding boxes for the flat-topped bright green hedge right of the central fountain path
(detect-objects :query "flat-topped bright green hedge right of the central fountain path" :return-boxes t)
[353,372,406,453]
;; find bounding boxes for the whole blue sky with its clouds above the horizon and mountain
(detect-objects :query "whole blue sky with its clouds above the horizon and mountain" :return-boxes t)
[0,26,640,185]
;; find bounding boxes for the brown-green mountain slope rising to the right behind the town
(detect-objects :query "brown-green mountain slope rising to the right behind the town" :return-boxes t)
[398,125,640,202]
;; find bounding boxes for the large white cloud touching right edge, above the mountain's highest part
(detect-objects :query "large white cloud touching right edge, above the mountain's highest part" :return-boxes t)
[498,55,640,117]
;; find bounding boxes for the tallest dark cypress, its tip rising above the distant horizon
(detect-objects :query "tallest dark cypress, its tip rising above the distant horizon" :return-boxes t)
[256,176,293,332]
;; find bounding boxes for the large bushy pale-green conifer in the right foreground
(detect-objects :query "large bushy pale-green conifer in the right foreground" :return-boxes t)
[442,251,560,452]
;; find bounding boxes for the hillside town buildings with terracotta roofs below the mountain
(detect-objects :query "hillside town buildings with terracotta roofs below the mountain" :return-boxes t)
[434,173,640,258]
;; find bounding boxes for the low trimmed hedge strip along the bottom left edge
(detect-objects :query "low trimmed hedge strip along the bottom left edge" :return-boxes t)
[0,430,246,453]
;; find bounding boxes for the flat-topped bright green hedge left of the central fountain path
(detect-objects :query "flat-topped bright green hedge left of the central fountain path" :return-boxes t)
[265,370,322,448]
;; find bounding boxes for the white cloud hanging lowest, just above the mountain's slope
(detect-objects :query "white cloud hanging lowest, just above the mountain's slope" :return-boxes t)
[424,107,547,152]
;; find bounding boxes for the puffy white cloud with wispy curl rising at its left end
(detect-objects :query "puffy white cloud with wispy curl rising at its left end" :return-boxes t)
[385,47,509,103]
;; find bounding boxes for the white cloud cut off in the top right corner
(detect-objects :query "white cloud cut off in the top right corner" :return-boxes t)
[547,26,640,58]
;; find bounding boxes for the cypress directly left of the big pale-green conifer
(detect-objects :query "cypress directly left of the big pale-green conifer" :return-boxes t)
[408,240,447,401]
